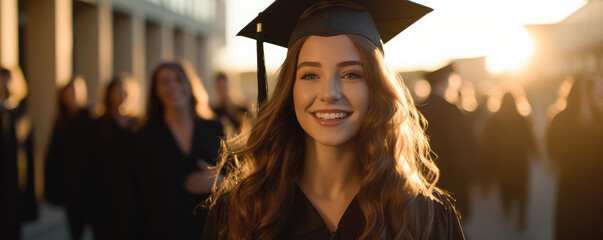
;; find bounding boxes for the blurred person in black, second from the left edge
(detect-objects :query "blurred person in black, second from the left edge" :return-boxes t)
[44,76,95,239]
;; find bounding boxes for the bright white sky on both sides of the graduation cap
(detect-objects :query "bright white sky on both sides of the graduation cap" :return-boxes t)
[216,0,587,71]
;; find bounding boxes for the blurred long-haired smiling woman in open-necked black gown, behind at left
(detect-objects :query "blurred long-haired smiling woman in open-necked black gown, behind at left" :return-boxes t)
[134,62,224,239]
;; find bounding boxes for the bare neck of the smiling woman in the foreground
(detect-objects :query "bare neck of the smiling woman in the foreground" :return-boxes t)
[298,136,362,199]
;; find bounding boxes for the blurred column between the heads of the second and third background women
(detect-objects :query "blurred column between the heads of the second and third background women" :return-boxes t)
[73,1,113,110]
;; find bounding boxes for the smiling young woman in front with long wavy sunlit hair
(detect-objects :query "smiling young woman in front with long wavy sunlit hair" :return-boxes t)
[202,1,463,239]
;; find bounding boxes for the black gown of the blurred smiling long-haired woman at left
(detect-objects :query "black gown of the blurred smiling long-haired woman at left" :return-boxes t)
[134,120,223,240]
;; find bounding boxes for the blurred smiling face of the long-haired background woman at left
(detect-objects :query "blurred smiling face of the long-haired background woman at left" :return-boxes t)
[156,67,191,109]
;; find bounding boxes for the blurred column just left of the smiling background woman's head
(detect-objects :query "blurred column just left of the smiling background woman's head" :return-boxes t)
[113,13,148,116]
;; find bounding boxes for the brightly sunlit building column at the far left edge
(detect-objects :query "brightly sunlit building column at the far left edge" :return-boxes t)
[0,0,19,68]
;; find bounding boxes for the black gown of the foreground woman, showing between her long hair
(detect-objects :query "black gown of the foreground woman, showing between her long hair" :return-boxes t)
[201,187,464,240]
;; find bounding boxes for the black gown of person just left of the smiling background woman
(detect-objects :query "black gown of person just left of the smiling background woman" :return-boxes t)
[91,116,135,240]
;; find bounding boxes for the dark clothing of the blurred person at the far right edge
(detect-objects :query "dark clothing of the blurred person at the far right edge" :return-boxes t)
[547,111,603,239]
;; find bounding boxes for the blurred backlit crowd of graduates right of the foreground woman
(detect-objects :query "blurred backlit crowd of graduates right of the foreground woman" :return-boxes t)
[418,65,603,239]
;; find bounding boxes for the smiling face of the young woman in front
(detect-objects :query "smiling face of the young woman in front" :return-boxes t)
[293,35,369,146]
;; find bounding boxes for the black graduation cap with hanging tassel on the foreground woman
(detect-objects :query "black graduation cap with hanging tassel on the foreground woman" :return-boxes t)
[237,0,432,105]
